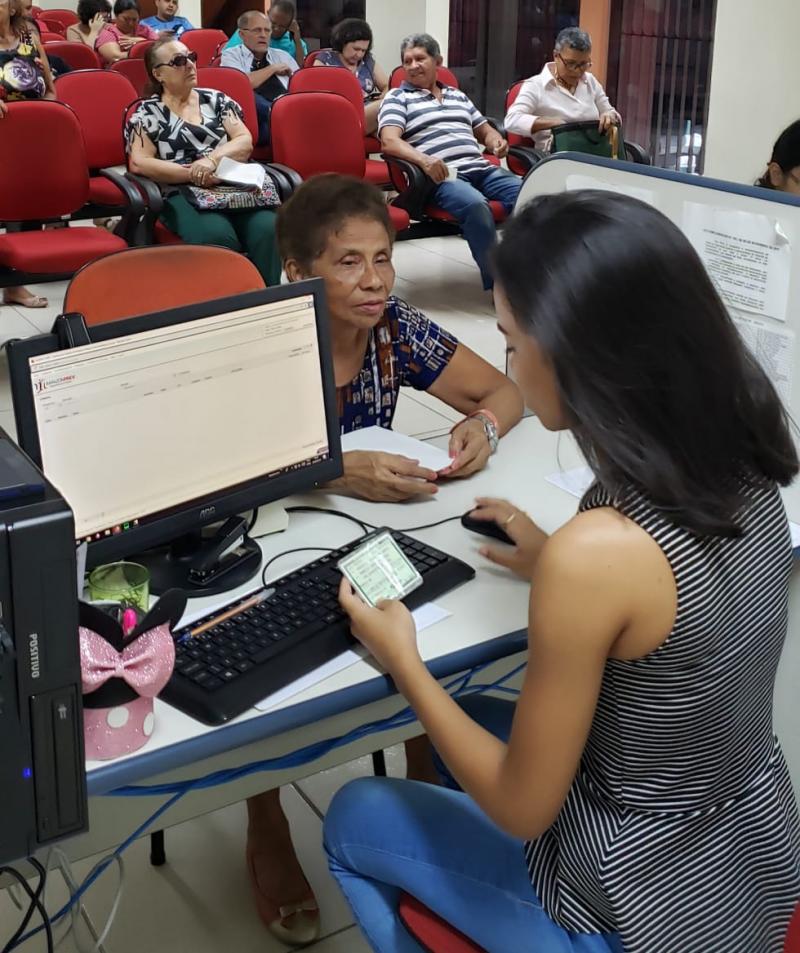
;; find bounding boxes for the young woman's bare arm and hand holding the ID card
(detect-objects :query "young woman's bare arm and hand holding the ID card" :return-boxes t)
[340,510,655,839]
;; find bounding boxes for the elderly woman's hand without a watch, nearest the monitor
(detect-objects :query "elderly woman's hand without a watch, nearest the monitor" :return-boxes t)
[343,450,437,503]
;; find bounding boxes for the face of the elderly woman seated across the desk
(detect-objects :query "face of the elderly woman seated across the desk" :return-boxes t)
[298,218,394,329]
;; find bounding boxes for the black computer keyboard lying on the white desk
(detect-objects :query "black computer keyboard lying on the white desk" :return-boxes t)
[159,529,475,725]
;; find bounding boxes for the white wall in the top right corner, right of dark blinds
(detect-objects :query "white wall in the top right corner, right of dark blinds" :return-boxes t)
[705,0,800,184]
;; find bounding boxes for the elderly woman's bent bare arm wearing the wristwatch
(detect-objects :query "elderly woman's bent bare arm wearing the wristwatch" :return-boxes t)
[428,344,524,476]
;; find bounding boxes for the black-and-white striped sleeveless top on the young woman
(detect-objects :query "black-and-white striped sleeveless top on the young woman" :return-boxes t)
[525,485,800,953]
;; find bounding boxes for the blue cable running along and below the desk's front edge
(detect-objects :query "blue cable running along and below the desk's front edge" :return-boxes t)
[11,662,527,950]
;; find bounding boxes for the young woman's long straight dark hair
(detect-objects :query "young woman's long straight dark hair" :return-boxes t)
[494,191,798,536]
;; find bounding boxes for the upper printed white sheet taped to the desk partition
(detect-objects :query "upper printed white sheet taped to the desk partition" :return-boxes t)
[683,202,792,321]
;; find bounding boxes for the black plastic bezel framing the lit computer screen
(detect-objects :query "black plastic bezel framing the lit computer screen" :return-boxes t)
[7,278,343,567]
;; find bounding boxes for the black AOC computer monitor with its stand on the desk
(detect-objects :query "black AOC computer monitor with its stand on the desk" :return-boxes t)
[9,279,342,595]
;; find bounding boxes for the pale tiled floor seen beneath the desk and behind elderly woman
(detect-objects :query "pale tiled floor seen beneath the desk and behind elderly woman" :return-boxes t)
[0,237,504,953]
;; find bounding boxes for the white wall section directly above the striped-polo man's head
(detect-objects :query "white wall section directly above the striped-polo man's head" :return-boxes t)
[367,0,450,73]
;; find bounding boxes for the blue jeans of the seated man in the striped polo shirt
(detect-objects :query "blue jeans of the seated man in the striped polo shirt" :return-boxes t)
[431,167,522,289]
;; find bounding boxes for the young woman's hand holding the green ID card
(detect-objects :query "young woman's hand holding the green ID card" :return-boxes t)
[339,578,422,676]
